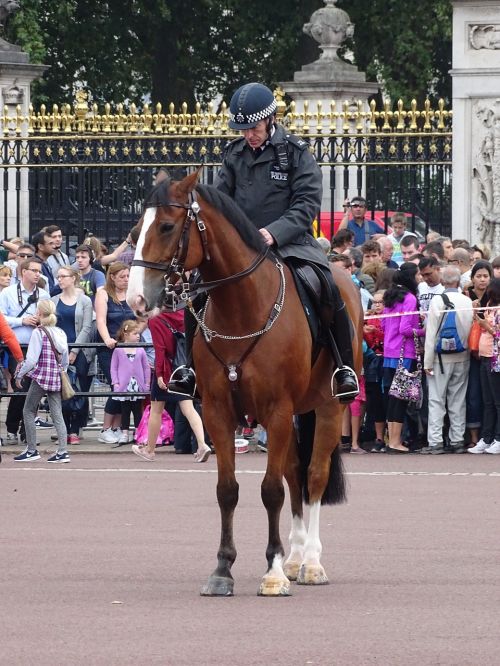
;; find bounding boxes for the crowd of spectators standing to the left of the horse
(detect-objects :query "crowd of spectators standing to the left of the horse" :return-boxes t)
[0,225,209,462]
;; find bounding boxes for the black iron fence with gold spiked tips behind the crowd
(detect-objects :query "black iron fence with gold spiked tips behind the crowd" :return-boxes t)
[0,94,451,245]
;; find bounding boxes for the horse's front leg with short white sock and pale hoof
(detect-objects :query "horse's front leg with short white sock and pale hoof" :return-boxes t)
[259,412,293,597]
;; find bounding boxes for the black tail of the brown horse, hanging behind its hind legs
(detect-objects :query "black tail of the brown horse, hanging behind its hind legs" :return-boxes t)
[297,412,347,504]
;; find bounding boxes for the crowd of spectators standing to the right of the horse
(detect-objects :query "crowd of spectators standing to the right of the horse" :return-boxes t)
[323,197,500,454]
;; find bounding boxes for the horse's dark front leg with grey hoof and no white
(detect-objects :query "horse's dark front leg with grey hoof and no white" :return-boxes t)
[200,412,239,597]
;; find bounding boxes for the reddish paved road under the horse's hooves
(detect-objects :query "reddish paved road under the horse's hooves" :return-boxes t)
[0,453,500,666]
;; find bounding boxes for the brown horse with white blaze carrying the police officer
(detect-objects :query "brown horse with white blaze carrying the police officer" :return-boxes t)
[127,174,362,596]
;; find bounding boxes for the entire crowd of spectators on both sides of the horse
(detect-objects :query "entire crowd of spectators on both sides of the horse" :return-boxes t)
[0,197,500,460]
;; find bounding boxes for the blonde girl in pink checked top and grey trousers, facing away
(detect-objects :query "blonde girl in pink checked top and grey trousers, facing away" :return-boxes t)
[14,300,70,463]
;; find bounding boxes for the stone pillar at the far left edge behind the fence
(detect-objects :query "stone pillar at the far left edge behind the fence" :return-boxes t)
[0,26,47,238]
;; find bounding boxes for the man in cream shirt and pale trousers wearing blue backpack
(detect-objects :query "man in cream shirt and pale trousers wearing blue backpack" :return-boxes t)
[422,266,473,454]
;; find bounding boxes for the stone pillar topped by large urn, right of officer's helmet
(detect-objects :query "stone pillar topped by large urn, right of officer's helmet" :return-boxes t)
[280,0,379,210]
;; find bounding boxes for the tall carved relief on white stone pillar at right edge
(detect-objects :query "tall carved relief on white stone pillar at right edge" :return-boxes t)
[471,99,500,252]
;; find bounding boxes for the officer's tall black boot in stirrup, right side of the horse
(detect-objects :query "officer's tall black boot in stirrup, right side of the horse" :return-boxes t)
[330,303,359,403]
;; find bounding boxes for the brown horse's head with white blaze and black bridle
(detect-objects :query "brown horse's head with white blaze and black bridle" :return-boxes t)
[127,171,204,315]
